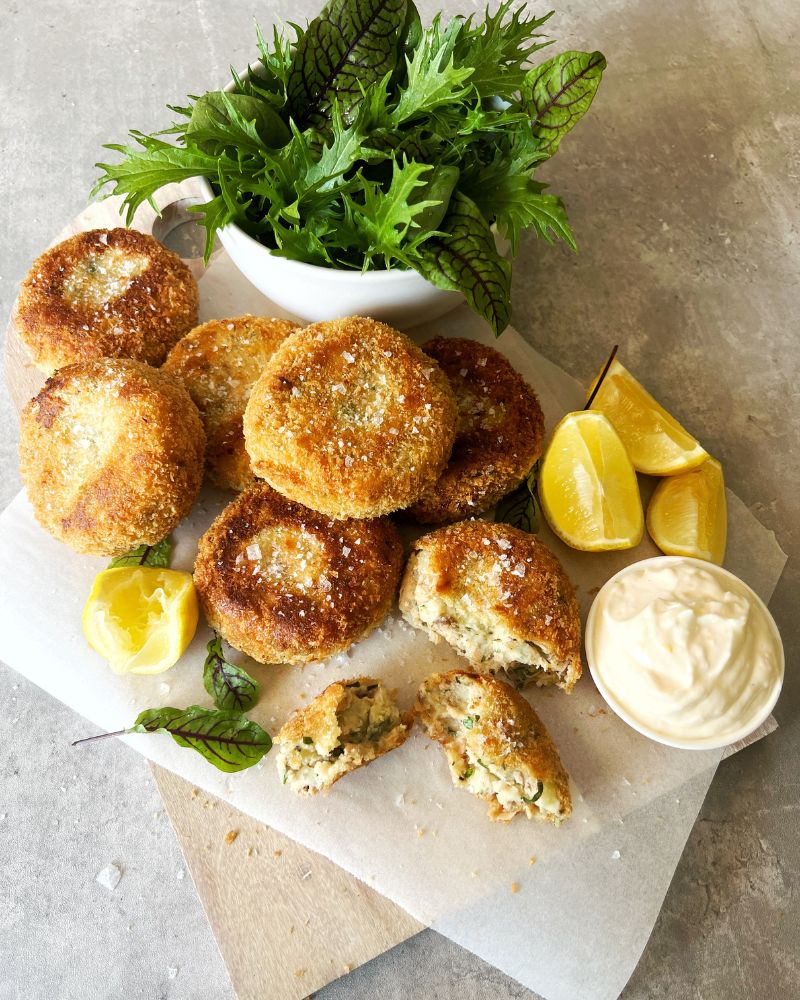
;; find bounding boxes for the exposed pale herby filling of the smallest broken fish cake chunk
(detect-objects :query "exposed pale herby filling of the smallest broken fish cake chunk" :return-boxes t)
[279,681,406,794]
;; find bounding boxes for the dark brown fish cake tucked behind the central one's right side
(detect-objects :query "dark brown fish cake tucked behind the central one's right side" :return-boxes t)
[408,337,544,524]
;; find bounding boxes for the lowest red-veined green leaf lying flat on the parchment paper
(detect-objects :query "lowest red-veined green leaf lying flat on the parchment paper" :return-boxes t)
[130,705,272,772]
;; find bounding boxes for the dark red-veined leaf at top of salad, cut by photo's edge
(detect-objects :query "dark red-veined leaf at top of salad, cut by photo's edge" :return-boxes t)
[286,0,406,128]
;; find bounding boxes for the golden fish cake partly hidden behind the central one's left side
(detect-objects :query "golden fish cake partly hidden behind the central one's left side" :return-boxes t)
[164,316,298,490]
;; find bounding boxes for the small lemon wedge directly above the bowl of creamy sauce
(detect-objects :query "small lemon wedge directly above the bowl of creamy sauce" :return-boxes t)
[647,458,728,566]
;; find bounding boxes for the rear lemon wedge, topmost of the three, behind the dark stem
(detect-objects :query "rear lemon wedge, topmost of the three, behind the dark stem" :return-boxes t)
[589,359,708,476]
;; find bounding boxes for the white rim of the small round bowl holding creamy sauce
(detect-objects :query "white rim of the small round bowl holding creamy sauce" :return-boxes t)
[584,556,785,750]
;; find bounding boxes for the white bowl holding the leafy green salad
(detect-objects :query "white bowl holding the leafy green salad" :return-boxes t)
[197,177,464,328]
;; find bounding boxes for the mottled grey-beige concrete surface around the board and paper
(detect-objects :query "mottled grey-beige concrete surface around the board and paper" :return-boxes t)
[0,0,800,1000]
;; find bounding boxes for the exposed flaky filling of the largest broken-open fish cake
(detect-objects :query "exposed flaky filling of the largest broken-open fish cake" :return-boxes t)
[416,550,569,687]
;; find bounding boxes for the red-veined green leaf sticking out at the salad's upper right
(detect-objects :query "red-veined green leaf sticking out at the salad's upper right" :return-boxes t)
[522,52,606,156]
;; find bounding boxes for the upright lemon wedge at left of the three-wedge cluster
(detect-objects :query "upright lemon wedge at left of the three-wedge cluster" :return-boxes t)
[539,410,644,552]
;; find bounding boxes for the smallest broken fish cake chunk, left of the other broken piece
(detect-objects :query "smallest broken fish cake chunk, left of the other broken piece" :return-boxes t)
[275,677,411,795]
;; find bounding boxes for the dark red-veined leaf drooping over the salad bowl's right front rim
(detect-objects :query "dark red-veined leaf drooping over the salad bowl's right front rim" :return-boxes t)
[418,191,511,337]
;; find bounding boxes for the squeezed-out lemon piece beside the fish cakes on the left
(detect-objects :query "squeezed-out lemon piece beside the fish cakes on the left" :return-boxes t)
[83,566,198,674]
